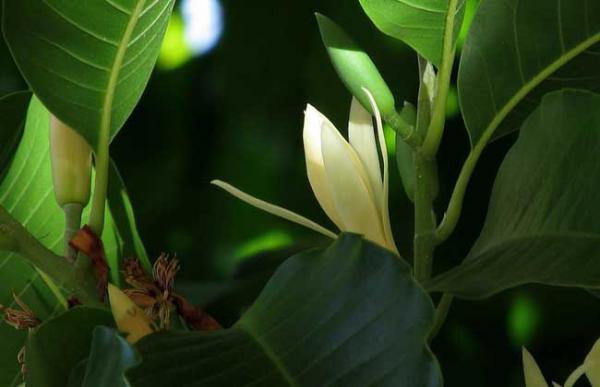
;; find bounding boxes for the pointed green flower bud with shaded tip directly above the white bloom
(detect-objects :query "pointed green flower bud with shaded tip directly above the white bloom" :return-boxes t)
[316,13,411,138]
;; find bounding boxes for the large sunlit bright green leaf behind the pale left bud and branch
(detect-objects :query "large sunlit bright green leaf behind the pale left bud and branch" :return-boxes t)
[0,98,120,386]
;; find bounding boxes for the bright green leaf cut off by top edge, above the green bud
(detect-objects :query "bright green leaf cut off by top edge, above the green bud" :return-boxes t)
[360,0,464,67]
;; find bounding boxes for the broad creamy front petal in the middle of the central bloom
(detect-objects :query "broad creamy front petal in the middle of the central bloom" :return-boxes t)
[321,123,387,247]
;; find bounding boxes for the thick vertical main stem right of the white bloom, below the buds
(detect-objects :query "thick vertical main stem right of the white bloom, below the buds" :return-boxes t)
[414,150,436,282]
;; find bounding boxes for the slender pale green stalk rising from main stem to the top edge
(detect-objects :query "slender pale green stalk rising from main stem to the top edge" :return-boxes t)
[423,0,458,157]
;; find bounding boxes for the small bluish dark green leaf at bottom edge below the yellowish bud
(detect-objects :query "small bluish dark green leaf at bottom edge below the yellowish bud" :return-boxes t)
[69,326,139,387]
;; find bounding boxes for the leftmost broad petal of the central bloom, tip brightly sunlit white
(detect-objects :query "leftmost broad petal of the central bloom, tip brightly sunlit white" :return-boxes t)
[302,105,343,229]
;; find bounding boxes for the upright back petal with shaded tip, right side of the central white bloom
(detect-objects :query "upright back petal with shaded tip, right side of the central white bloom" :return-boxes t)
[348,98,383,211]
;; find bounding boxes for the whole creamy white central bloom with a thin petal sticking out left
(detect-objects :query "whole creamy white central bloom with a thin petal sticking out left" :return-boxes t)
[213,90,398,253]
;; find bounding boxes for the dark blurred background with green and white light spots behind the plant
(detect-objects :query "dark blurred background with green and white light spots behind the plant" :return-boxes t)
[0,0,600,387]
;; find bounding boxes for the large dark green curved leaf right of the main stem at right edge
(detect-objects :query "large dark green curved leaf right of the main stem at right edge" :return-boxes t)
[429,90,600,298]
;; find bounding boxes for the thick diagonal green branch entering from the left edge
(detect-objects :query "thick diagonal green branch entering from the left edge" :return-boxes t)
[0,207,98,305]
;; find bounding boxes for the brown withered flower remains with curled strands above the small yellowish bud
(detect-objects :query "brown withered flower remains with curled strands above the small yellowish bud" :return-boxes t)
[123,254,221,330]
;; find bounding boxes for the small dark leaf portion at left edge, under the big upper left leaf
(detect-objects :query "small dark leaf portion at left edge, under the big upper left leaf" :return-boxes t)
[0,91,31,175]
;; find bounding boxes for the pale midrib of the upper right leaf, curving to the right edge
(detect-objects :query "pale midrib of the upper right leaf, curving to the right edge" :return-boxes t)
[468,32,600,151]
